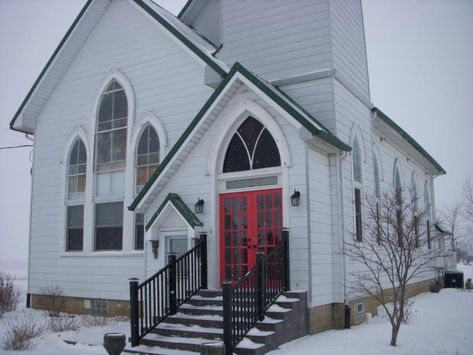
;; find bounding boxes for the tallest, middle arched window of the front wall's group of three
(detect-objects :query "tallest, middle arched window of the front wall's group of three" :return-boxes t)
[95,80,128,250]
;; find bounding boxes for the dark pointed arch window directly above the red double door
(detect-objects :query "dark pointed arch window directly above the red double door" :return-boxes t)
[223,117,281,173]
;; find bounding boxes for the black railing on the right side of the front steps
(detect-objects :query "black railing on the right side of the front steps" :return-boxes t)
[223,231,290,354]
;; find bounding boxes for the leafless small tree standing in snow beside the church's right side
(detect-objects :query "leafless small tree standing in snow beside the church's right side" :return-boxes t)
[345,189,434,346]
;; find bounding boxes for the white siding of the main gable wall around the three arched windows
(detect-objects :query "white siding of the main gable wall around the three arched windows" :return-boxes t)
[28,0,212,300]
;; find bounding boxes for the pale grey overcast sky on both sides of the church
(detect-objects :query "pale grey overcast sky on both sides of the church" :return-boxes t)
[0,0,473,267]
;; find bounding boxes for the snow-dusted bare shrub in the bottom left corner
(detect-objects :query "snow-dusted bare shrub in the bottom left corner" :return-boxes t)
[2,314,45,351]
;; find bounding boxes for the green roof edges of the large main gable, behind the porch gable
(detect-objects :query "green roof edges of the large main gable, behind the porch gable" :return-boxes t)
[10,0,227,133]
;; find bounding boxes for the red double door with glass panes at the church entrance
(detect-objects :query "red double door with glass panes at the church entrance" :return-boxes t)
[220,189,282,282]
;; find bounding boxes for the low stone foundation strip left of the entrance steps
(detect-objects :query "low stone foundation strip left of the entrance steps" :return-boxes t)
[30,294,130,317]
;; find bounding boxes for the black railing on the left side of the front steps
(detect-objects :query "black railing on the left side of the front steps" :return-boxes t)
[130,235,207,346]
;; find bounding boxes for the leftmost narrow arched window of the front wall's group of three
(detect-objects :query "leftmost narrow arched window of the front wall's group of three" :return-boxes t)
[66,139,87,251]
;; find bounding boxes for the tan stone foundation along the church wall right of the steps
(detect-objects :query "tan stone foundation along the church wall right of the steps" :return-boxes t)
[308,279,435,334]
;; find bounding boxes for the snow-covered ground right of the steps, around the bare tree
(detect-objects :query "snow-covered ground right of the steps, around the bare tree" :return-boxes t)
[270,264,473,355]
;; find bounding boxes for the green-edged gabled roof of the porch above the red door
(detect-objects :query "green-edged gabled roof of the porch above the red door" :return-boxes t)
[128,62,351,211]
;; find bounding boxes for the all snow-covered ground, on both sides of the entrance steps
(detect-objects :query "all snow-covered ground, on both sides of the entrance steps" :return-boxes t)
[0,264,473,355]
